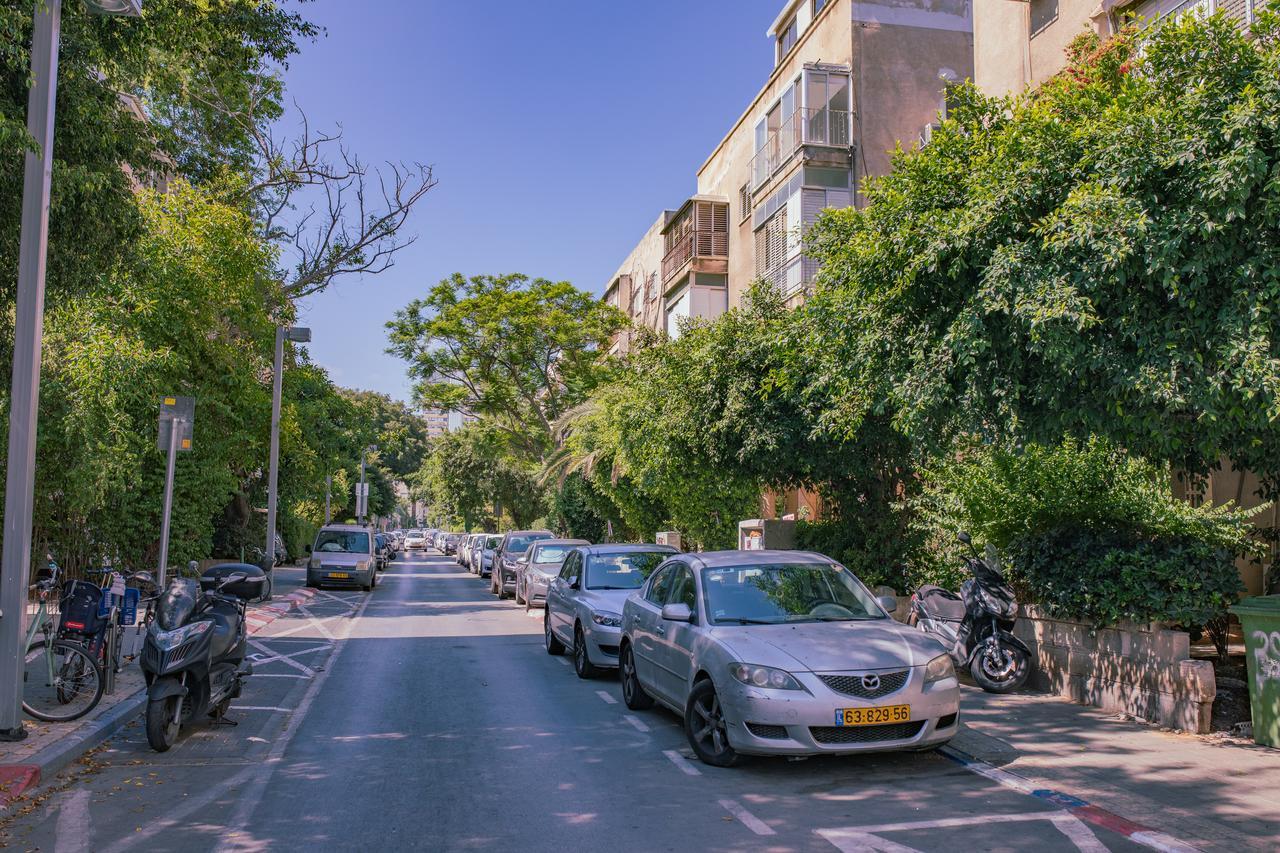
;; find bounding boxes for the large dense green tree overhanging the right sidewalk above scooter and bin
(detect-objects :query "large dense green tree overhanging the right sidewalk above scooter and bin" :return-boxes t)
[805,12,1280,491]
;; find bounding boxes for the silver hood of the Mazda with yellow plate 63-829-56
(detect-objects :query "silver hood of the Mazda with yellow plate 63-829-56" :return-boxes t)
[716,619,943,672]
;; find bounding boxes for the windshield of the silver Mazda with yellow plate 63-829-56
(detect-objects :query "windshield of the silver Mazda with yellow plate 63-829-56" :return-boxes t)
[703,564,886,625]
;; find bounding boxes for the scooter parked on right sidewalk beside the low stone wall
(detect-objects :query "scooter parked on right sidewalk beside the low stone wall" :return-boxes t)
[906,533,1032,693]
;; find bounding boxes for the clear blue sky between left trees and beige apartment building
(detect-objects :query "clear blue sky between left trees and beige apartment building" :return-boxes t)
[284,0,782,400]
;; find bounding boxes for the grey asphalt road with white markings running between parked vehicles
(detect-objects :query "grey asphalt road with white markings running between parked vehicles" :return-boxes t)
[0,556,1162,853]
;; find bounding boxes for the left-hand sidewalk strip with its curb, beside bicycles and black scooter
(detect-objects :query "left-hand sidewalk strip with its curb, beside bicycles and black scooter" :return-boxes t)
[0,566,315,813]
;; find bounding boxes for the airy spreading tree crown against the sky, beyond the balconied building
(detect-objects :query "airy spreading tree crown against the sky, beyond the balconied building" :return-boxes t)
[387,274,625,464]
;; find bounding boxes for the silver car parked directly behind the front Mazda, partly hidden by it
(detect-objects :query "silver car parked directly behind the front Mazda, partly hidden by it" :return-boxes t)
[543,544,678,679]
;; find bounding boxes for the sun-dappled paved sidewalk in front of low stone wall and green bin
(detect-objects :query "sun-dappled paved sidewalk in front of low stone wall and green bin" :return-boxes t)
[951,686,1280,852]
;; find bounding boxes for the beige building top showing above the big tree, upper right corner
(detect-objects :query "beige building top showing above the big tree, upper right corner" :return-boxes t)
[973,0,1265,96]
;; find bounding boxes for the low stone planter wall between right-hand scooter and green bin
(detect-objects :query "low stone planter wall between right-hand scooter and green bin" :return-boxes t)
[1015,607,1217,734]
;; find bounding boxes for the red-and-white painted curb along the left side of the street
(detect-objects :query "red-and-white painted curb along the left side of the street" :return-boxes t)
[0,588,316,816]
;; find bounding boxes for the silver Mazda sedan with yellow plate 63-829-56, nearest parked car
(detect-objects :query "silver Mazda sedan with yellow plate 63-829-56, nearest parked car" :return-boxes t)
[618,551,960,767]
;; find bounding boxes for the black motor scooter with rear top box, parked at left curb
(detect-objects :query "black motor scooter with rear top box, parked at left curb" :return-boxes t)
[138,564,266,752]
